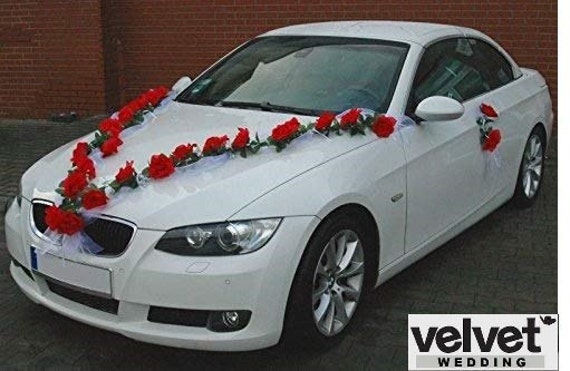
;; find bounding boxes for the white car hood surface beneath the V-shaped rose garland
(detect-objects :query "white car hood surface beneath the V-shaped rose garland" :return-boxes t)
[22,102,374,230]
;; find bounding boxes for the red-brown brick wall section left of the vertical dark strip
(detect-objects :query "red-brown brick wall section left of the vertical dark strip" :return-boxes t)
[0,0,105,117]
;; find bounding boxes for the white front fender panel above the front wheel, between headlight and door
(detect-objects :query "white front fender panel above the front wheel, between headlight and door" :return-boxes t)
[229,136,406,268]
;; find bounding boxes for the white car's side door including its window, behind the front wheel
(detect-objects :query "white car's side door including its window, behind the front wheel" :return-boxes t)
[405,38,512,252]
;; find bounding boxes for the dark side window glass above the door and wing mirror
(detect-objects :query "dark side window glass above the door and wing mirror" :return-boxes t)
[407,38,513,113]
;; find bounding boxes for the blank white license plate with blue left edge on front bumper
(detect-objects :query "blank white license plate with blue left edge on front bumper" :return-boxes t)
[30,246,112,296]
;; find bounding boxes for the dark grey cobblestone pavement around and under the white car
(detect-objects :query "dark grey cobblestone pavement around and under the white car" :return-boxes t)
[0,119,557,370]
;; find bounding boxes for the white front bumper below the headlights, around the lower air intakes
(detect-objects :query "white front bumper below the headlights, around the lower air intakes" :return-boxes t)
[6,200,318,351]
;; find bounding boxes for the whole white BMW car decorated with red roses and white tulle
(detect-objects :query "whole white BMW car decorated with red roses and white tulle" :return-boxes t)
[5,21,553,351]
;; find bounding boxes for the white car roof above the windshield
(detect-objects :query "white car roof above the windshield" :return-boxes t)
[262,21,464,46]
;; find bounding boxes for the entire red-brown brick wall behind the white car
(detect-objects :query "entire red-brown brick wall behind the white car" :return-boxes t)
[0,0,557,117]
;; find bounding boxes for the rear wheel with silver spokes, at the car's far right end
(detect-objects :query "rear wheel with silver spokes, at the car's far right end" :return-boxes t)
[513,125,546,209]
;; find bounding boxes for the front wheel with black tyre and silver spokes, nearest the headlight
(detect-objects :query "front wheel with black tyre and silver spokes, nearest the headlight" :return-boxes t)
[282,211,377,350]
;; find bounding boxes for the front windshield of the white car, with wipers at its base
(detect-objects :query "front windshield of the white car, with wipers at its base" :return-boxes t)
[177,36,408,115]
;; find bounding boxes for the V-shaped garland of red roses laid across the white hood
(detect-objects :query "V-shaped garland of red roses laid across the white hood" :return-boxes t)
[45,101,396,236]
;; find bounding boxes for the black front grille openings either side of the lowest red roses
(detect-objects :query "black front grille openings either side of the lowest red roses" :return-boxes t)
[32,201,135,256]
